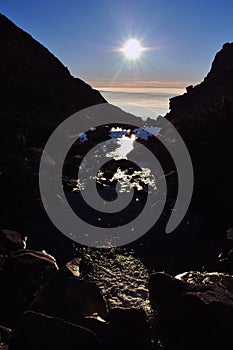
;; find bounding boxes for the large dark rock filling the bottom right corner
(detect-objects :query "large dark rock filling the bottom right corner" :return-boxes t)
[149,273,233,350]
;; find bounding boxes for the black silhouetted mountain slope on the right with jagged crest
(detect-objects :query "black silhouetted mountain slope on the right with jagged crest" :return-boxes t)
[166,43,233,231]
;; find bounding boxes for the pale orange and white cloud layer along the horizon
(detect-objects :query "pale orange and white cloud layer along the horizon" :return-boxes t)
[89,80,197,119]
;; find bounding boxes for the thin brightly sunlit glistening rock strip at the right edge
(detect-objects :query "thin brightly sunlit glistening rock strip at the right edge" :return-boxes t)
[176,271,233,293]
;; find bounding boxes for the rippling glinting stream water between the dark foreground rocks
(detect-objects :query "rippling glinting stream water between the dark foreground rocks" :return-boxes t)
[76,248,152,315]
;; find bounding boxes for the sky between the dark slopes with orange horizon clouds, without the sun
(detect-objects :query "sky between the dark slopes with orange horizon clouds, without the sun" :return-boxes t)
[0,0,233,114]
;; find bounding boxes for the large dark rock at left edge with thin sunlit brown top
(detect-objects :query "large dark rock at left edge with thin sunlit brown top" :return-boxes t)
[0,249,58,326]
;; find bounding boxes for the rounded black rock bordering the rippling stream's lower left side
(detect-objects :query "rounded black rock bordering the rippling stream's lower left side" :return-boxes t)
[31,269,108,322]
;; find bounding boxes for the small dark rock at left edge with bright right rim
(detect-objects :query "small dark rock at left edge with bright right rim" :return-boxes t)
[0,229,27,251]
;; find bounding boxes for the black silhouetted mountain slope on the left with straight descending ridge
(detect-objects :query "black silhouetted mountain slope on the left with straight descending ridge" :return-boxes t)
[0,14,106,232]
